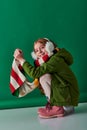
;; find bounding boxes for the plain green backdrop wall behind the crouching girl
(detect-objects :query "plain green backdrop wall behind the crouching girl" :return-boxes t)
[0,0,87,109]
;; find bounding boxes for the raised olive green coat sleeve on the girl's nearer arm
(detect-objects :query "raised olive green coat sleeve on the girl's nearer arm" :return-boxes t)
[23,52,64,79]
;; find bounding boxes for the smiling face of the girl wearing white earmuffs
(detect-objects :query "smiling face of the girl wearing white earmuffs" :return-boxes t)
[34,42,47,59]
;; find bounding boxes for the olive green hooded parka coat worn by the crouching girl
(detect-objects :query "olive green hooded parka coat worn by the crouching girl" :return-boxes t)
[23,48,79,106]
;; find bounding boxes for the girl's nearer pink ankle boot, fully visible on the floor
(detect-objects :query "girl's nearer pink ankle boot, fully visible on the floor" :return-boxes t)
[39,106,65,118]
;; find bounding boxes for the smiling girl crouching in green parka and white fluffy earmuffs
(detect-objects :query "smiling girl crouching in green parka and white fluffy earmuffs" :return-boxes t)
[14,38,79,118]
